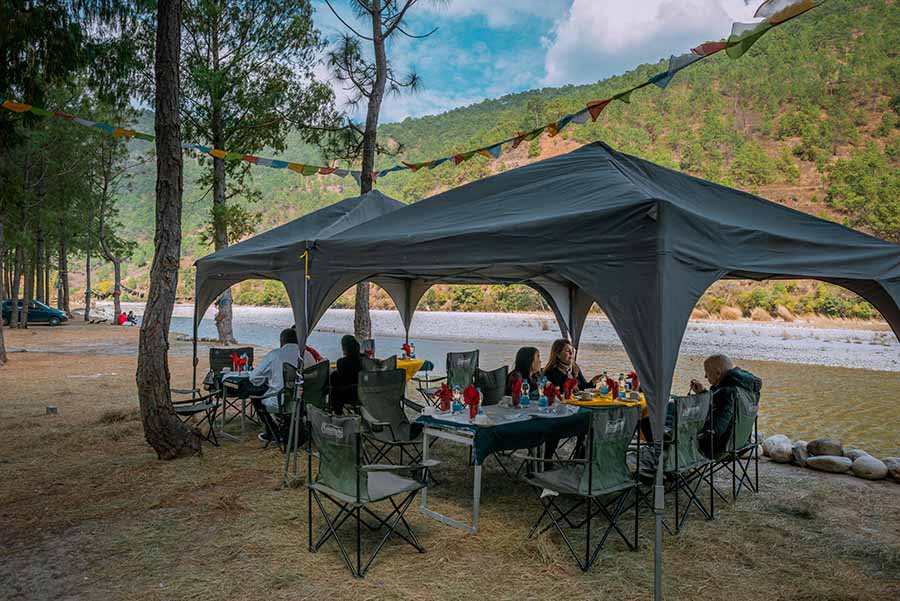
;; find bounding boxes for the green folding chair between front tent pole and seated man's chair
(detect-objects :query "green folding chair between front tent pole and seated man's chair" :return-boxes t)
[656,390,712,533]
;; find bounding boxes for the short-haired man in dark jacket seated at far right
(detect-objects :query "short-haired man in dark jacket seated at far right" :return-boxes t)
[691,355,762,455]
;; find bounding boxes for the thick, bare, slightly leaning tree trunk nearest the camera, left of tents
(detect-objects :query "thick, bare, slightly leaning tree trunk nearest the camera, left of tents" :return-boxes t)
[136,0,200,459]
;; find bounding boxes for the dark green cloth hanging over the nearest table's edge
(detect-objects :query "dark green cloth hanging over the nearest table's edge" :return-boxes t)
[416,409,590,464]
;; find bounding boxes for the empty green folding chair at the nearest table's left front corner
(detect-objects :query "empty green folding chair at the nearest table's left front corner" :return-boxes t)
[307,407,438,578]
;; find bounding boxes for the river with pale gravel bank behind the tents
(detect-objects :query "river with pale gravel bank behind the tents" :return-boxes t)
[160,306,900,456]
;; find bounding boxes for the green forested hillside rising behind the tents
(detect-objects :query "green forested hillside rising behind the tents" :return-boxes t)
[103,0,900,316]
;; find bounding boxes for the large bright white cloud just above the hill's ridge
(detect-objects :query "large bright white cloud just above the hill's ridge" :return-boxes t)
[544,0,757,85]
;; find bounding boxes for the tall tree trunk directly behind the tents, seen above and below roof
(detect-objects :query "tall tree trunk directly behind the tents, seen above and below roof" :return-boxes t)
[353,0,387,340]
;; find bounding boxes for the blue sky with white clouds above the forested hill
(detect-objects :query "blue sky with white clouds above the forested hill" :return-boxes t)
[313,0,761,122]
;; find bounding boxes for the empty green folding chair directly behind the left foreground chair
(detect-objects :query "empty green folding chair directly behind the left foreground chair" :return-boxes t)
[357,369,422,464]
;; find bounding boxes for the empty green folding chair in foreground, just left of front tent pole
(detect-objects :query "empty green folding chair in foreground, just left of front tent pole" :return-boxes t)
[516,406,641,572]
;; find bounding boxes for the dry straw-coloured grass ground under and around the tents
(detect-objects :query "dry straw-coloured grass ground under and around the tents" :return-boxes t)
[0,324,900,601]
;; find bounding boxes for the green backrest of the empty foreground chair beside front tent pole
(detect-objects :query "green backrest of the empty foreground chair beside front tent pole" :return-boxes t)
[578,405,641,494]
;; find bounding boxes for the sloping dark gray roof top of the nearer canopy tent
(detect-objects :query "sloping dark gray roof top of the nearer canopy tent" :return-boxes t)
[319,142,900,288]
